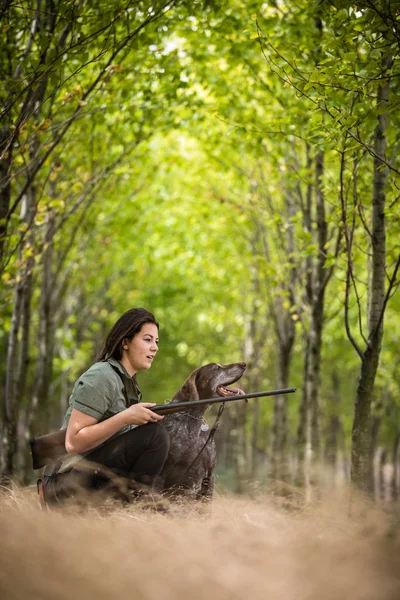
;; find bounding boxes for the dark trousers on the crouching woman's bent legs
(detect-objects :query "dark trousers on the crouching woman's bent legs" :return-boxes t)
[45,423,169,503]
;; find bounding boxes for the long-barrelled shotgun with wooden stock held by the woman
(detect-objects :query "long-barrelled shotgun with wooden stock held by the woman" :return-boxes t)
[29,388,296,470]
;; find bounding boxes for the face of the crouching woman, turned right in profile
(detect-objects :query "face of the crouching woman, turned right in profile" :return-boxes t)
[121,323,158,377]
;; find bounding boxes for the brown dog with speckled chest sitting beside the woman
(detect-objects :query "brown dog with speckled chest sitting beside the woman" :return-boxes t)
[157,363,246,499]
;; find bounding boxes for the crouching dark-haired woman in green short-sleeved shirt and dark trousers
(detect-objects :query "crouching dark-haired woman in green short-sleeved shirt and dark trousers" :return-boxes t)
[48,308,169,497]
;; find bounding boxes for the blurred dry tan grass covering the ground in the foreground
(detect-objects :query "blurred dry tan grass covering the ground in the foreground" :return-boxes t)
[0,482,400,600]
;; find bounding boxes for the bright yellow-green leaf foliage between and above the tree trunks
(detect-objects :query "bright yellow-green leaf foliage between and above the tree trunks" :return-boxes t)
[0,0,400,478]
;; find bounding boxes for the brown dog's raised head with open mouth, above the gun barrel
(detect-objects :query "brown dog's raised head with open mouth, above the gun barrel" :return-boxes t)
[179,362,246,402]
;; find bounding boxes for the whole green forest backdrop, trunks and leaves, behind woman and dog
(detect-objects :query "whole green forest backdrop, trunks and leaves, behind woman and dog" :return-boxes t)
[0,0,400,488]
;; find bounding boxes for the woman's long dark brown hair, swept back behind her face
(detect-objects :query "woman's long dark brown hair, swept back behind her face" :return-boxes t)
[98,308,160,360]
